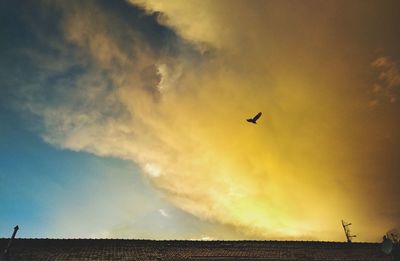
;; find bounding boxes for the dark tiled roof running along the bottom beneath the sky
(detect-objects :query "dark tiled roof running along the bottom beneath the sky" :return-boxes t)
[0,239,393,261]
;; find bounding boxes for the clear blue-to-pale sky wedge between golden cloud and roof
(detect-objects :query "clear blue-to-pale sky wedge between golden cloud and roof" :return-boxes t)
[0,71,242,239]
